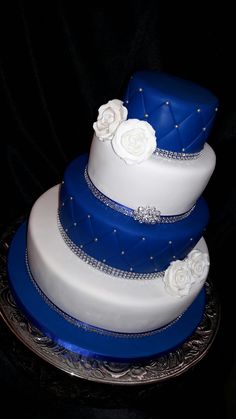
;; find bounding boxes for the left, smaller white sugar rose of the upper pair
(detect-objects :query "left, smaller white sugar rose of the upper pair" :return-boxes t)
[93,99,128,141]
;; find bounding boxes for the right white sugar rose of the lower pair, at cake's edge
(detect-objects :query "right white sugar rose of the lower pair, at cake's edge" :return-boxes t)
[187,249,210,282]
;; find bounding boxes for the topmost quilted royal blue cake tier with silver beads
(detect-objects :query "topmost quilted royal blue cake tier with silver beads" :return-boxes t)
[124,71,218,154]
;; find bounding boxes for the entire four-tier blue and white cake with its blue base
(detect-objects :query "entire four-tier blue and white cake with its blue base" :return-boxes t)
[8,71,218,360]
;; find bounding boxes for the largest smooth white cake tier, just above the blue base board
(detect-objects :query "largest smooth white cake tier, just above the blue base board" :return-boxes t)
[27,185,208,333]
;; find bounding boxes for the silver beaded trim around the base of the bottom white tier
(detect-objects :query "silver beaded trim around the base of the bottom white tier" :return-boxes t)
[25,250,183,339]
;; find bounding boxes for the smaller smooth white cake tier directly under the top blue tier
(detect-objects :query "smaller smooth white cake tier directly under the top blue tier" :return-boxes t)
[88,136,216,215]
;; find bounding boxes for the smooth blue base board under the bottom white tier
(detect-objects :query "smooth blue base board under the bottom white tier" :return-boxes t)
[7,223,205,361]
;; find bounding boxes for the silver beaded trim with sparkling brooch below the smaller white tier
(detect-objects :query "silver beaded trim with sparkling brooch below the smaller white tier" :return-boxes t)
[84,166,195,224]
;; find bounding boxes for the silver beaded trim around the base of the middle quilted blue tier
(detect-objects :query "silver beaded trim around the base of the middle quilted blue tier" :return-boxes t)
[58,214,165,279]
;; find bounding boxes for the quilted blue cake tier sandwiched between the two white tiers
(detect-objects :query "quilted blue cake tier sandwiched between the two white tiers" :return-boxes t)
[59,155,209,274]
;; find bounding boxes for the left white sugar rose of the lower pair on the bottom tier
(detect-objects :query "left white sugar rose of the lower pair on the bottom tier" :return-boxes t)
[163,260,192,297]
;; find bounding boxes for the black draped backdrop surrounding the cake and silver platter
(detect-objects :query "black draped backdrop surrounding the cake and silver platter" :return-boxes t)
[0,0,236,418]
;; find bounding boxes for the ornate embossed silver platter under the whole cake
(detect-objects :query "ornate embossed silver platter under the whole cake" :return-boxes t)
[0,219,220,385]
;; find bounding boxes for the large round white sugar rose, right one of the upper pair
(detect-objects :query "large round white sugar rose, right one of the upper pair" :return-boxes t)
[112,119,156,164]
